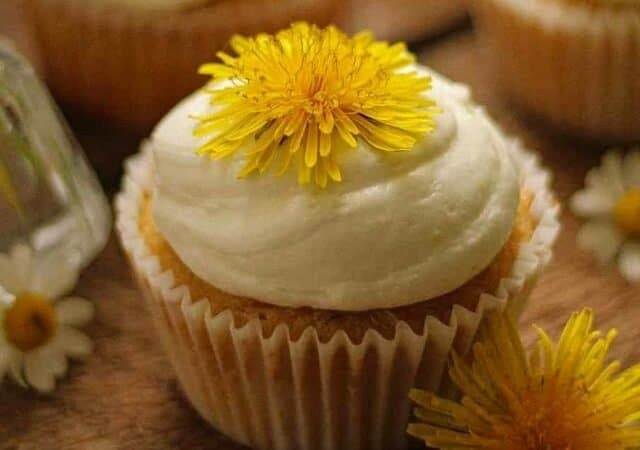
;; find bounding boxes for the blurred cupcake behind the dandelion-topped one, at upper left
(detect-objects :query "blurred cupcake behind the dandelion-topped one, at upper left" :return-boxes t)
[25,0,335,132]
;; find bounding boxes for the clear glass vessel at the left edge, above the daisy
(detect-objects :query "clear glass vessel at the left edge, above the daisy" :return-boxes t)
[0,40,111,282]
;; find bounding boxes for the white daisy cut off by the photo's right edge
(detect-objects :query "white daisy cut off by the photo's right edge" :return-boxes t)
[570,149,640,282]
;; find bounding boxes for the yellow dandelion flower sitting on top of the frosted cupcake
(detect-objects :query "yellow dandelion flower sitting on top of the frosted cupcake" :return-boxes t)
[195,23,437,187]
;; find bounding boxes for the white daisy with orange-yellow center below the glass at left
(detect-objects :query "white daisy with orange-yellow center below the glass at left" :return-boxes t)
[0,245,94,392]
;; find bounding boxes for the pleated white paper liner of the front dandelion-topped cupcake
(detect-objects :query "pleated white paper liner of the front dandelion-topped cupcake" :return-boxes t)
[116,141,559,450]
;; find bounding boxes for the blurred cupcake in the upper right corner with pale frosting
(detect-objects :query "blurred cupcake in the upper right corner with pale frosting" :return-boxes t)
[471,0,640,141]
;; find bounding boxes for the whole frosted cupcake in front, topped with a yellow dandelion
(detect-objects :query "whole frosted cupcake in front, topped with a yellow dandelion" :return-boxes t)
[116,23,559,449]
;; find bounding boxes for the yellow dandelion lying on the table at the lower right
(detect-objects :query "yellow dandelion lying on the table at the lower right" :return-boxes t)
[409,309,640,450]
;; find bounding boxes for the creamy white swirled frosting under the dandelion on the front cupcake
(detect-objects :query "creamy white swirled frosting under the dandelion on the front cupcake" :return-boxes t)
[151,68,519,311]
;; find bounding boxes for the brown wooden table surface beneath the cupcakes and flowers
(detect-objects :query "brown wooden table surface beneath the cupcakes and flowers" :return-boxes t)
[0,0,640,450]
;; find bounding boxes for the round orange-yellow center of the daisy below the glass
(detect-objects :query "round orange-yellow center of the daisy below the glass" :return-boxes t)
[4,293,58,352]
